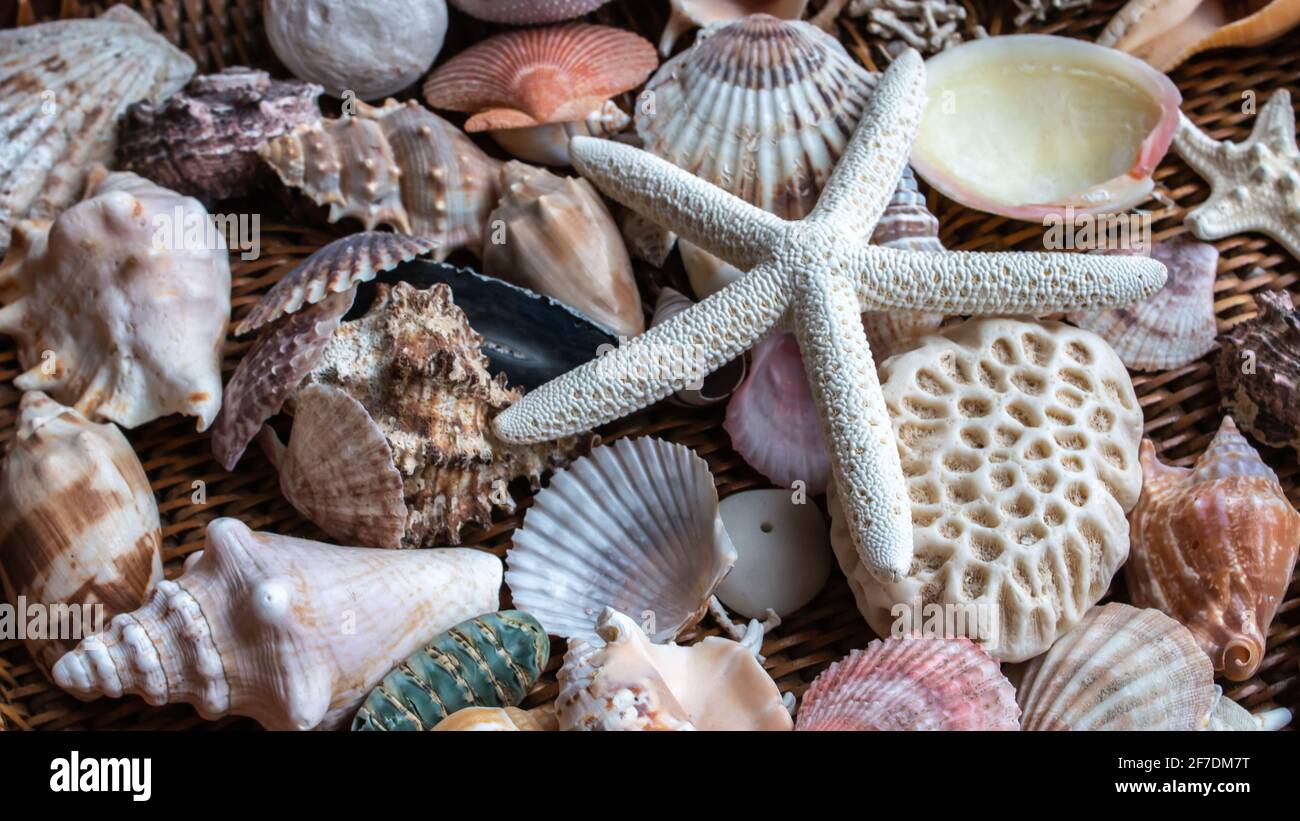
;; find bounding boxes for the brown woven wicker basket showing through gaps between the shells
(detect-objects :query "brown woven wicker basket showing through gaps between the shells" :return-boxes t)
[0,0,1300,730]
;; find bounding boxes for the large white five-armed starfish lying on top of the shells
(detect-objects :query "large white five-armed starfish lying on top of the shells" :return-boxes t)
[495,49,1165,579]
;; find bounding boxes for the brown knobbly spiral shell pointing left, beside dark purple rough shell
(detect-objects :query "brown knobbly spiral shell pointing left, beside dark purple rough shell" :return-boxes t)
[257,100,502,260]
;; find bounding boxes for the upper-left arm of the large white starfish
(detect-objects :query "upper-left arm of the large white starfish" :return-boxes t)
[569,136,785,270]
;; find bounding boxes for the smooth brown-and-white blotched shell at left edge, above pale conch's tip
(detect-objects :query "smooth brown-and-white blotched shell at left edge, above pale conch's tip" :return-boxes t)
[0,392,163,669]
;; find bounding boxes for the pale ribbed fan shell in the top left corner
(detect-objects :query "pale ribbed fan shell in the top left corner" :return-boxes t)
[0,5,195,256]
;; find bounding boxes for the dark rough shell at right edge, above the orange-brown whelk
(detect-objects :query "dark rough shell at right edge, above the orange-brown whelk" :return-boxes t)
[1216,291,1300,452]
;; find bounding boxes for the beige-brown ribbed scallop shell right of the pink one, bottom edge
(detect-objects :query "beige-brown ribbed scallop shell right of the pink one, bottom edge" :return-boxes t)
[1015,603,1217,730]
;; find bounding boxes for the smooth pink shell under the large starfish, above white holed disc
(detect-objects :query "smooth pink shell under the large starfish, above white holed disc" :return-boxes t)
[723,333,831,496]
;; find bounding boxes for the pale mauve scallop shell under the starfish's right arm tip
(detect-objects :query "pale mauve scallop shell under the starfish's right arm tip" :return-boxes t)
[1070,235,1218,370]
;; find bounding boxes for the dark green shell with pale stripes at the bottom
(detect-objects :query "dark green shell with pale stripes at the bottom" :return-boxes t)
[352,611,551,730]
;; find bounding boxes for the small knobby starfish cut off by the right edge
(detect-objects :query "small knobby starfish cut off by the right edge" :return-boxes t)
[1174,88,1300,259]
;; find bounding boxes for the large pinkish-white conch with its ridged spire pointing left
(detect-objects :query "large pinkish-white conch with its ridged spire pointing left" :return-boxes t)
[53,518,501,730]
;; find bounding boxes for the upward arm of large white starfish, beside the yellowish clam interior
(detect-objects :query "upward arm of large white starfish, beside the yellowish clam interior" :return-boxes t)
[809,48,926,238]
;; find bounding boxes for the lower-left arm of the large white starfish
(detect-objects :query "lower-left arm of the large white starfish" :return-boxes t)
[494,265,789,443]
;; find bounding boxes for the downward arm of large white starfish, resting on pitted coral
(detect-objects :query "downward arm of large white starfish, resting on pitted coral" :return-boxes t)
[792,259,913,582]
